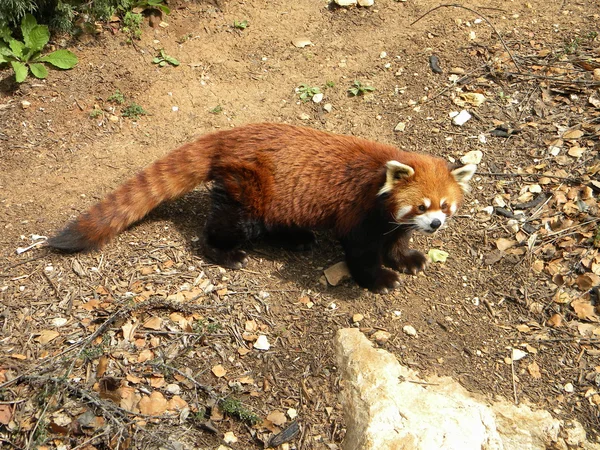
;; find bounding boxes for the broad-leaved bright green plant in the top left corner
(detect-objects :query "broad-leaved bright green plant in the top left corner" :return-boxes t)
[0,14,77,83]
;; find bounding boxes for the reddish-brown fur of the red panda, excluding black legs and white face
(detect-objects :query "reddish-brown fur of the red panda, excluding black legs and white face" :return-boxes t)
[49,123,462,255]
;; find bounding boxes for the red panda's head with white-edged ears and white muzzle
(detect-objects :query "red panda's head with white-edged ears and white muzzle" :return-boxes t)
[378,156,477,233]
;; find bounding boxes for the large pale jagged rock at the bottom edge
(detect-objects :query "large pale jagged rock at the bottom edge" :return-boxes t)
[335,328,600,450]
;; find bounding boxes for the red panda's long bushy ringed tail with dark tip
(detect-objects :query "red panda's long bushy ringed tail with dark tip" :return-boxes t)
[47,137,213,252]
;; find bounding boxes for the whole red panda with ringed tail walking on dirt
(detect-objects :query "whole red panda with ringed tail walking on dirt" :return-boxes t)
[48,123,476,293]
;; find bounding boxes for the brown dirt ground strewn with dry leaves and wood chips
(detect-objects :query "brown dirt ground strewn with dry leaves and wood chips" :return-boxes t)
[0,0,600,449]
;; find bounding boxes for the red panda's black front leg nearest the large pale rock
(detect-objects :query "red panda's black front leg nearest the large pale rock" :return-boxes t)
[341,238,400,294]
